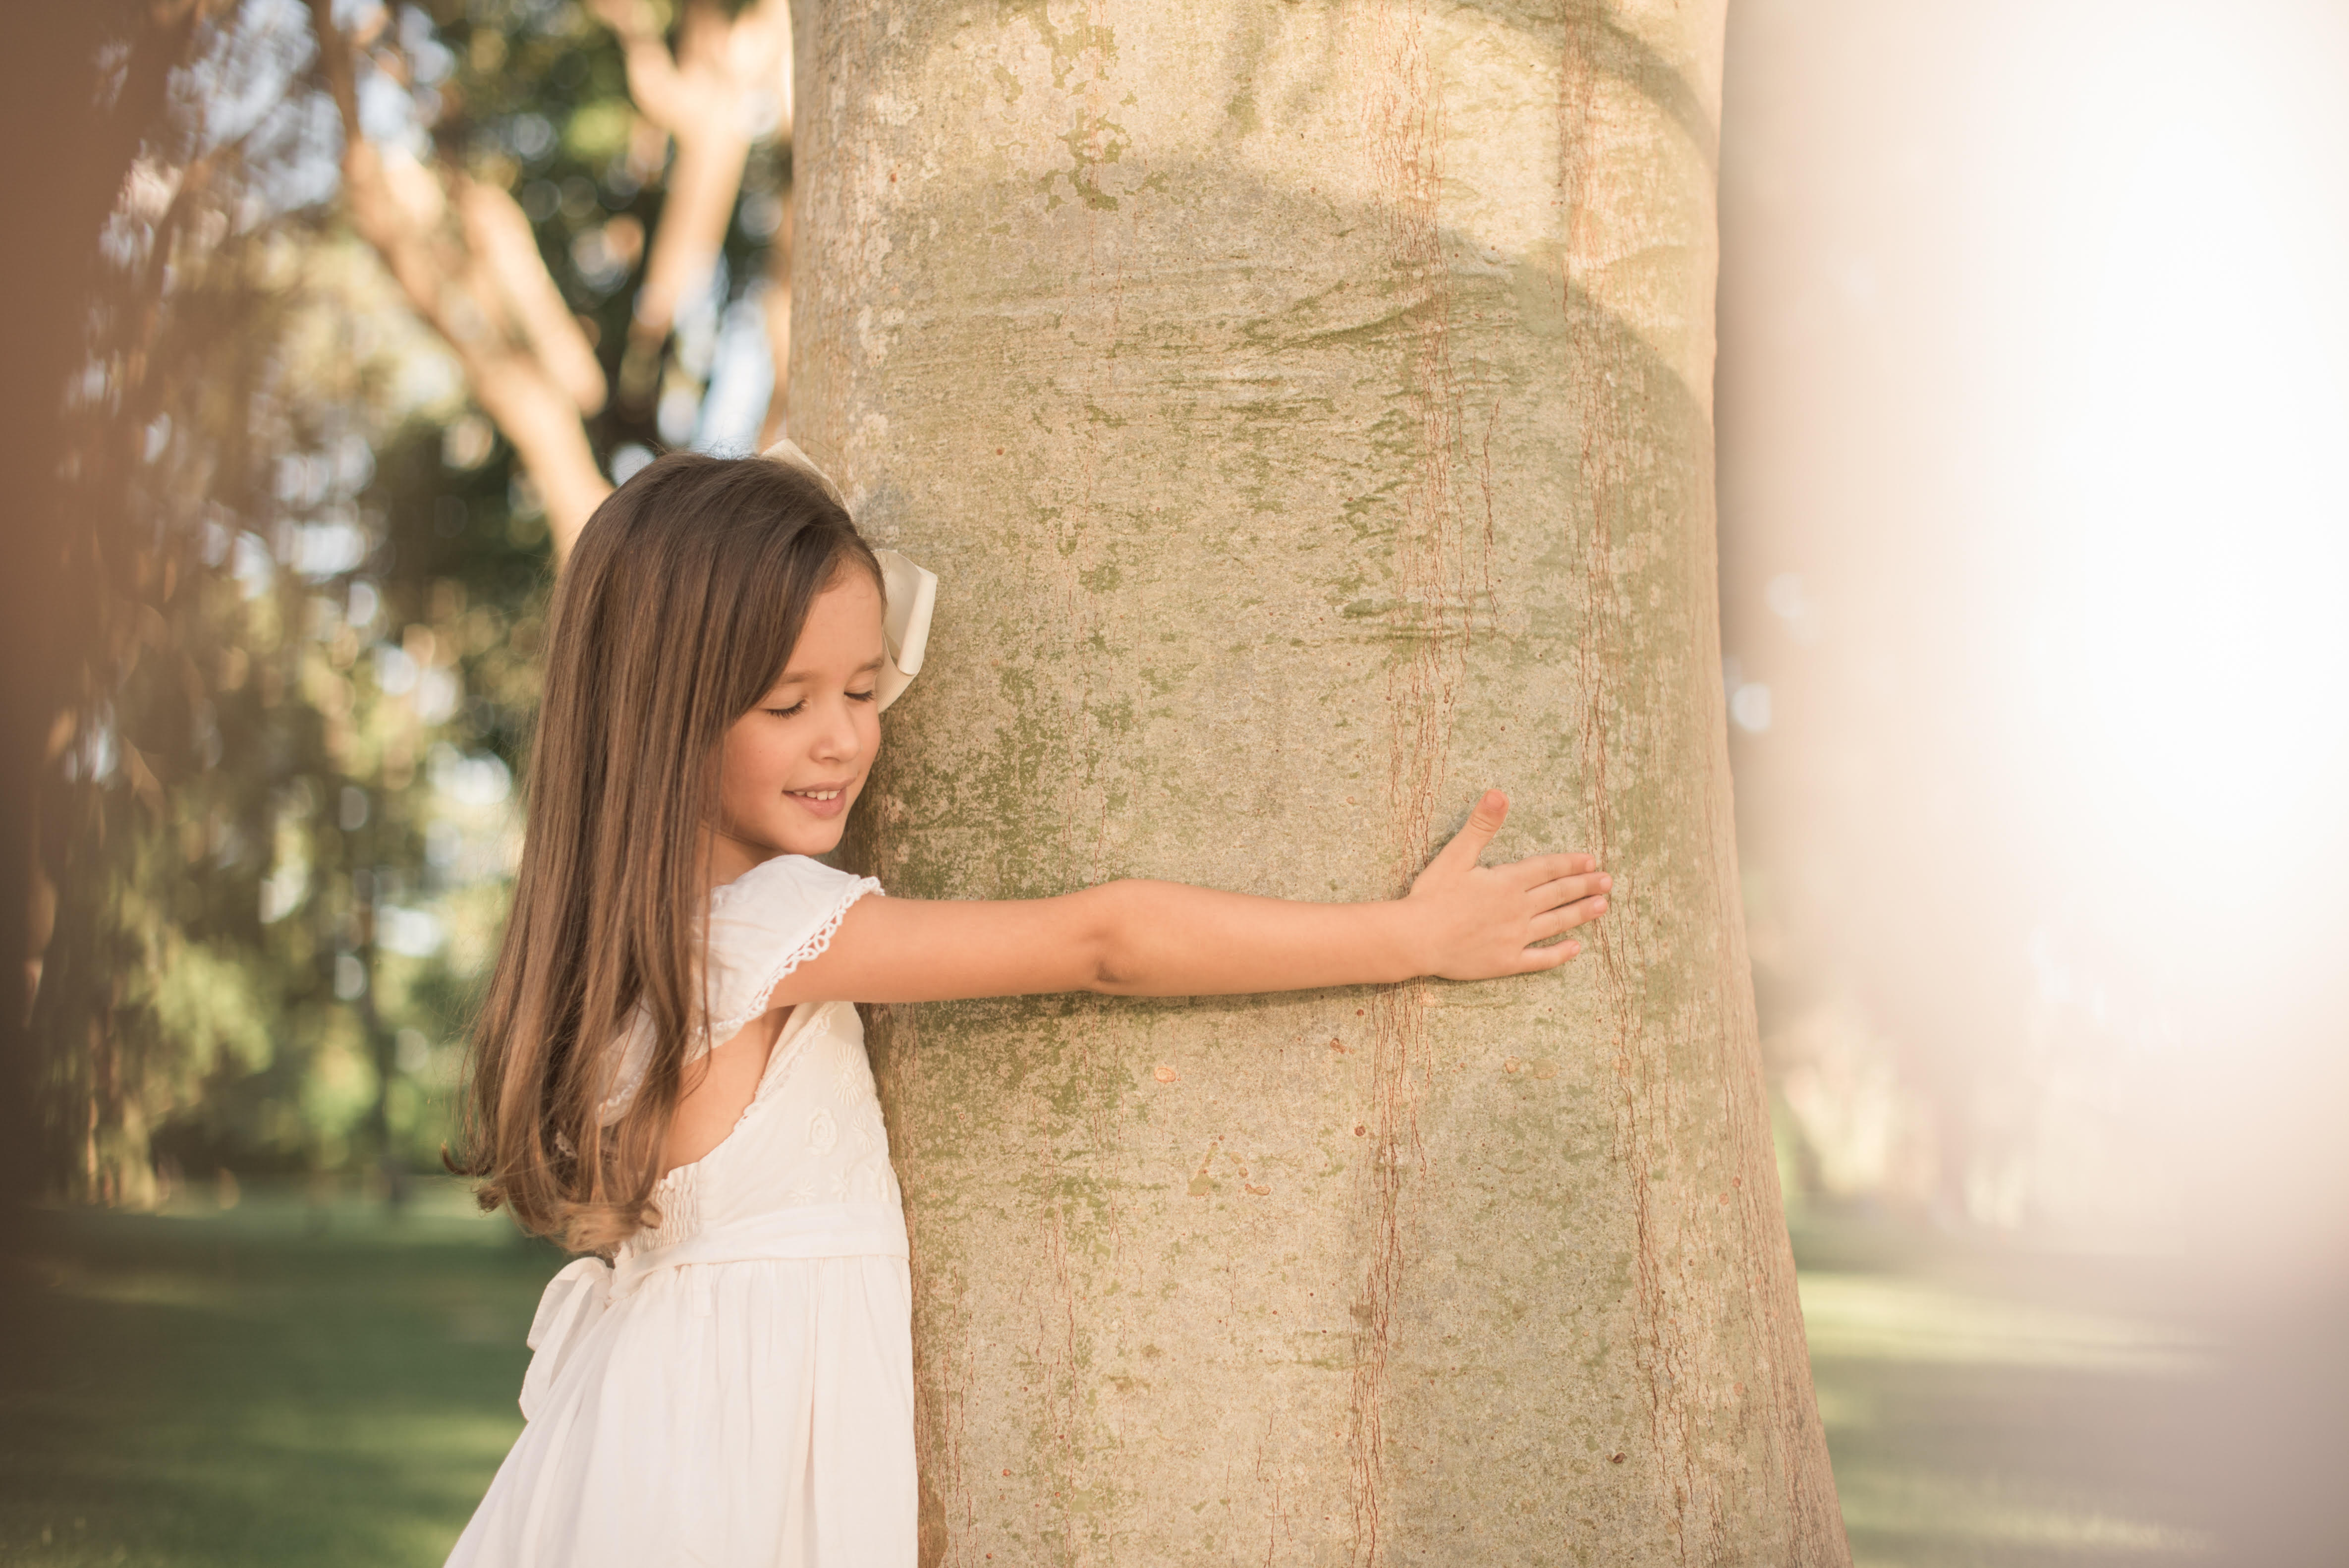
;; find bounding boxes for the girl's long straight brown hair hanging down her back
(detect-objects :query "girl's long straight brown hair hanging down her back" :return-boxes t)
[448,453,881,1251]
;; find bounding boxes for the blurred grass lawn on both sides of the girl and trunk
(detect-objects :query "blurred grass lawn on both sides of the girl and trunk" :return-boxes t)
[0,1183,2210,1568]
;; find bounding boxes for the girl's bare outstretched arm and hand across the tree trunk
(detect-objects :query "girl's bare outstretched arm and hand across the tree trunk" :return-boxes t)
[773,791,1612,1007]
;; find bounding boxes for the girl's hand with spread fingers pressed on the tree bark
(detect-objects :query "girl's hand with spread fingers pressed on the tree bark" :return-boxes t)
[1402,788,1614,979]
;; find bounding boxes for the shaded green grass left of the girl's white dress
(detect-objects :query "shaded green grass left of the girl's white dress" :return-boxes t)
[0,1183,557,1568]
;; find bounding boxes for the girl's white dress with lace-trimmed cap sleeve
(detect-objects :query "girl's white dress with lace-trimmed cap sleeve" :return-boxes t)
[448,854,916,1568]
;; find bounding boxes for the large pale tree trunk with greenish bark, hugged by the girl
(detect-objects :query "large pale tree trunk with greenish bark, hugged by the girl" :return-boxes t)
[791,0,1846,1568]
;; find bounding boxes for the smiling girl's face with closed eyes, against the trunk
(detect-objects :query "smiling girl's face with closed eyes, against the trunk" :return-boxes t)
[712,566,883,880]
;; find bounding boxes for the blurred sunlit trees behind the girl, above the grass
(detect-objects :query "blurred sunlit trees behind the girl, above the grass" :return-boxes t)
[28,0,789,1202]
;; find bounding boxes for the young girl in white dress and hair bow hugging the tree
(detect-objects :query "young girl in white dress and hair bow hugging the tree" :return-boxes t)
[448,448,1609,1568]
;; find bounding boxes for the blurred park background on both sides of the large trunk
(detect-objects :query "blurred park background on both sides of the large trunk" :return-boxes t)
[0,0,2349,1566]
